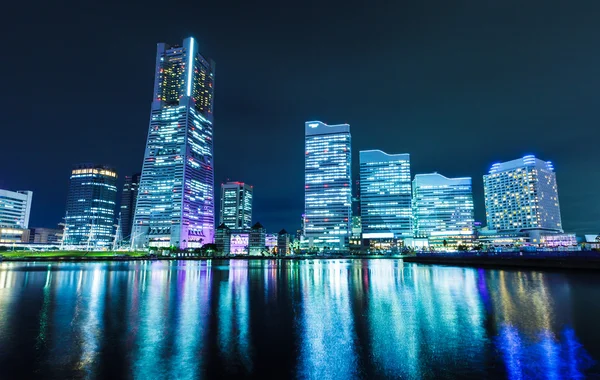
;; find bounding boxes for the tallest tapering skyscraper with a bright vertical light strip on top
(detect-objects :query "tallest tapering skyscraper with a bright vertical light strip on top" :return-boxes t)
[131,37,215,248]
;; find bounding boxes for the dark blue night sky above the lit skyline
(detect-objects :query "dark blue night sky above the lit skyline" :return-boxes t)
[0,0,600,233]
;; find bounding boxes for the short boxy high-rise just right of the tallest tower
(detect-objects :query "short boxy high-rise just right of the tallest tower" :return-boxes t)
[219,182,252,228]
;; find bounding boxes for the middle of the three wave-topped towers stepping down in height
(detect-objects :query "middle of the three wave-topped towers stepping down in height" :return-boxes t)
[360,150,413,239]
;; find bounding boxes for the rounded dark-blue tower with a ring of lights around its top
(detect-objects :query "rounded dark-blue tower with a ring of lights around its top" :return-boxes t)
[63,164,117,249]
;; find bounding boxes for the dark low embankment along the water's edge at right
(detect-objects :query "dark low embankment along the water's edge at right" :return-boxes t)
[403,256,600,271]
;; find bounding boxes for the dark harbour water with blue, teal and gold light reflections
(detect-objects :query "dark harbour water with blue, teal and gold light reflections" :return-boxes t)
[0,259,600,380]
